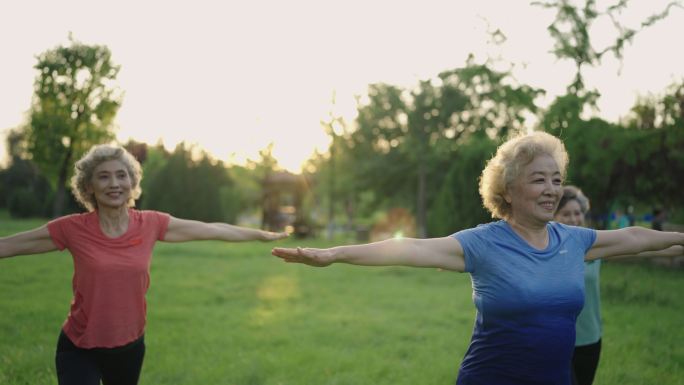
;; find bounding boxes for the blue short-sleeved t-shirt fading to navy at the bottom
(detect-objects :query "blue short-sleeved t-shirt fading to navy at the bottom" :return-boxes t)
[453,220,596,385]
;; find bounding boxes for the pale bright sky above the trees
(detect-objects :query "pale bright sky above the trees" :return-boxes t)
[0,0,684,171]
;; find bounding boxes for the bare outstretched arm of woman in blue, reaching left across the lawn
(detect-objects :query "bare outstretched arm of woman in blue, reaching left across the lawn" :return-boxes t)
[271,237,465,272]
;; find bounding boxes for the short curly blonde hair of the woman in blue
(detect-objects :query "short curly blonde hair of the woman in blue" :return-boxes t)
[480,131,568,219]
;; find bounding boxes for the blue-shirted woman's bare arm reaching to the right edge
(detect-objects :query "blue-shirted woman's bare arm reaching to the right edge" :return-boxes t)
[585,227,684,260]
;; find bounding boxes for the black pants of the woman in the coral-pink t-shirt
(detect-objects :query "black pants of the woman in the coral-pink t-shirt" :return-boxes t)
[55,332,145,385]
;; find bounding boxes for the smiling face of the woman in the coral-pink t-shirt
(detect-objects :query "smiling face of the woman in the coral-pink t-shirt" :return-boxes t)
[88,160,131,208]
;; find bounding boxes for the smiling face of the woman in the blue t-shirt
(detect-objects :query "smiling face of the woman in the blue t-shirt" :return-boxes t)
[505,155,563,225]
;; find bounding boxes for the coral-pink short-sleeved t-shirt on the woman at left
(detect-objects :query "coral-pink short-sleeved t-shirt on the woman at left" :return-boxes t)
[47,209,170,348]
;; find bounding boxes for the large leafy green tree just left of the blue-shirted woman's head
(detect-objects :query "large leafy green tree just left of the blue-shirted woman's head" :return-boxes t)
[349,57,543,237]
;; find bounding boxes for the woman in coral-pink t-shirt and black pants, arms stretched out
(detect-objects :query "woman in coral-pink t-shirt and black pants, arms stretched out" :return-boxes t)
[0,145,287,385]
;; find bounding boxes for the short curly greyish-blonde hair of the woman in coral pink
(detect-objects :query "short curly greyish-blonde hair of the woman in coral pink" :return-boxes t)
[71,144,142,211]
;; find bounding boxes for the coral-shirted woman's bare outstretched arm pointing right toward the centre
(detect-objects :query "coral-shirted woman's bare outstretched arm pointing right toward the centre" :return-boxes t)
[164,217,287,242]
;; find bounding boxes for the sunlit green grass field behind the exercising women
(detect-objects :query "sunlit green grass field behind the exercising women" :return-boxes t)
[0,218,684,385]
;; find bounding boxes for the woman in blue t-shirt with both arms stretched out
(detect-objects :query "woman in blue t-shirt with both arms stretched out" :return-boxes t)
[272,132,684,385]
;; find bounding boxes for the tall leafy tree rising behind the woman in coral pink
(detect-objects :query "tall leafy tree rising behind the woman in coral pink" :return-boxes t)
[26,37,121,216]
